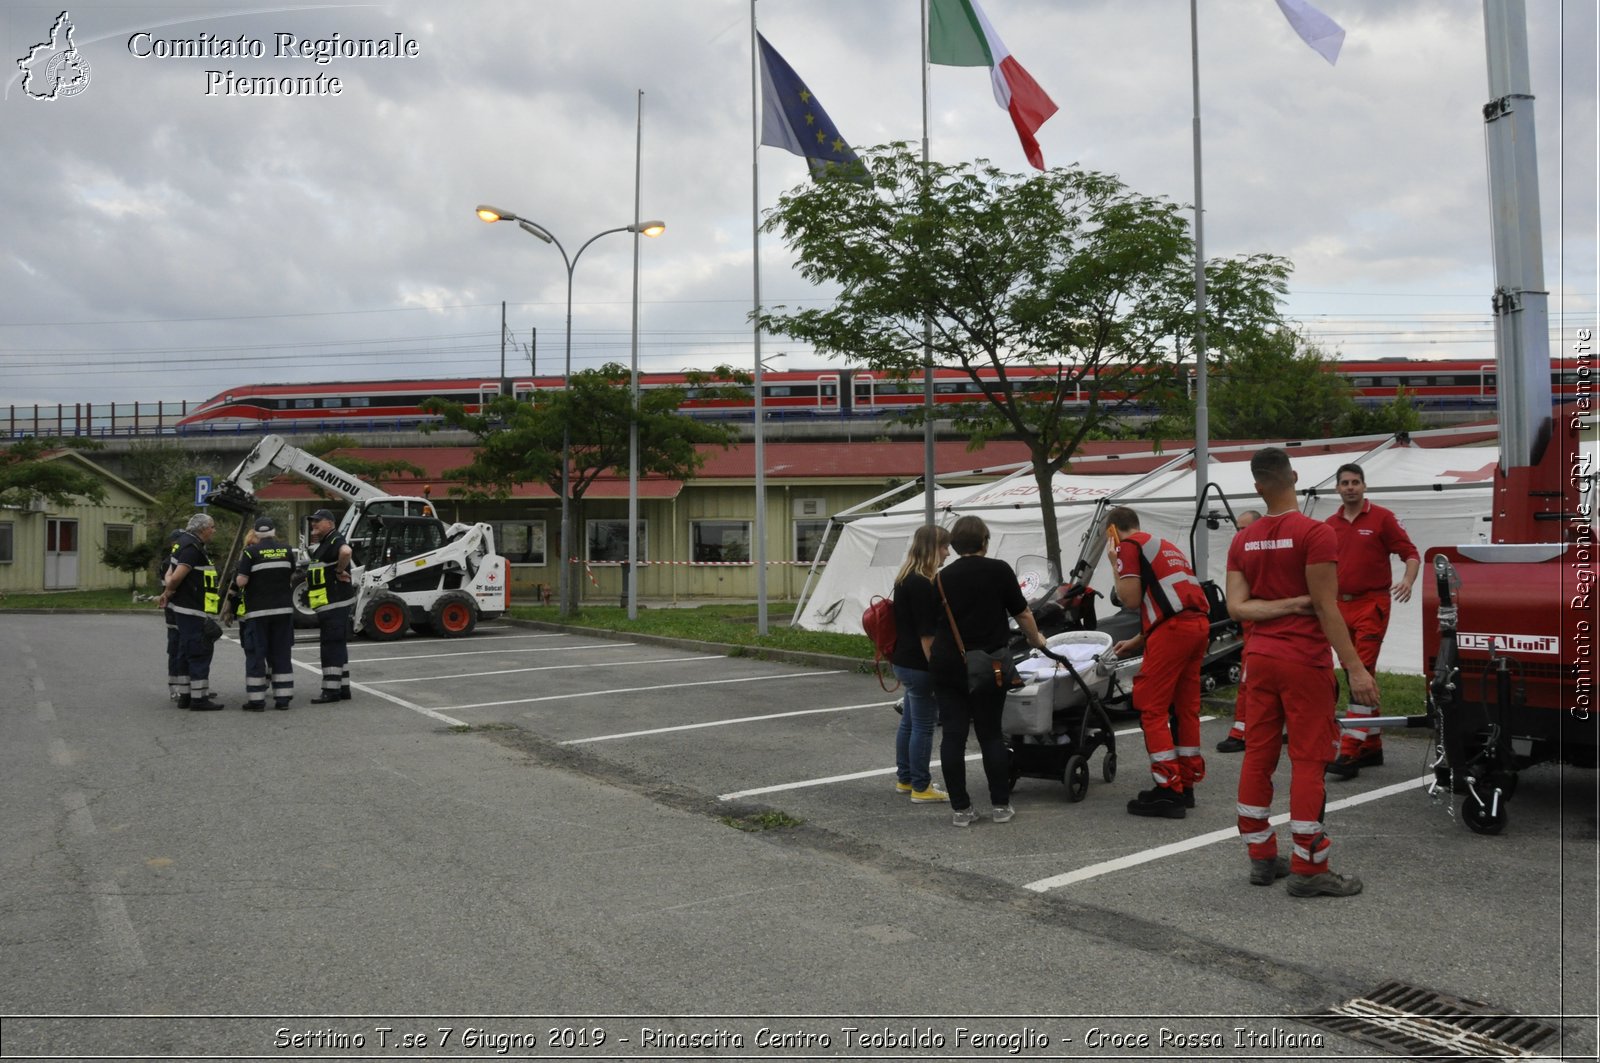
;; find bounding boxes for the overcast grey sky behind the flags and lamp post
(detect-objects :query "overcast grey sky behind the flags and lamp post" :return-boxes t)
[0,0,1597,405]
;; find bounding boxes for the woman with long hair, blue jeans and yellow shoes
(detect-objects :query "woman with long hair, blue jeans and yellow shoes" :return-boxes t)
[890,523,950,804]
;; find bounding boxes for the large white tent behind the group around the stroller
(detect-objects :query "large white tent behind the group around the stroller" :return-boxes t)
[797,443,1499,674]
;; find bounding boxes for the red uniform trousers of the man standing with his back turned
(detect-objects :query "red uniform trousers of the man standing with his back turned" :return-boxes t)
[1238,655,1339,874]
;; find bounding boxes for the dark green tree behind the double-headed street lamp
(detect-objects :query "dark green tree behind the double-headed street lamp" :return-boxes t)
[422,362,749,576]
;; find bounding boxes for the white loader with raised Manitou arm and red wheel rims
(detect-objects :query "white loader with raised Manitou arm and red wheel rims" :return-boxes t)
[206,435,510,640]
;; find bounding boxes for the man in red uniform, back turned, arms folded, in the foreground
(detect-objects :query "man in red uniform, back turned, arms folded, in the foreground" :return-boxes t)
[1227,447,1378,897]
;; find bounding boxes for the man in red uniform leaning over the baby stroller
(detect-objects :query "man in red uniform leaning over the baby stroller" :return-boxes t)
[1106,506,1211,820]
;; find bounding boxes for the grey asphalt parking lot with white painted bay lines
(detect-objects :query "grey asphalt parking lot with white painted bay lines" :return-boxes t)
[0,615,1597,1058]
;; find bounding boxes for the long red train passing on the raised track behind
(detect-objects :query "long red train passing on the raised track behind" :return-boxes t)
[179,359,1594,431]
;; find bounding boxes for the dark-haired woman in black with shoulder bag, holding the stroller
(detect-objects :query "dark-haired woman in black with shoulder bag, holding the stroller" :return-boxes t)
[928,515,1045,826]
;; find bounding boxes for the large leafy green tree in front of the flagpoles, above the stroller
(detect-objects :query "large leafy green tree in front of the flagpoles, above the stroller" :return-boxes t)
[762,144,1288,568]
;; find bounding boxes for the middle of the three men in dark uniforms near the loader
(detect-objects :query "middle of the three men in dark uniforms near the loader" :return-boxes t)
[234,517,294,712]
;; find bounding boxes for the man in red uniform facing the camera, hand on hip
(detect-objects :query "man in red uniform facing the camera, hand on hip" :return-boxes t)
[1328,461,1422,778]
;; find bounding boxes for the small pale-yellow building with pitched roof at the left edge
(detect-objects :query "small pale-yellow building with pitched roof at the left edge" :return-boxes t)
[0,450,157,594]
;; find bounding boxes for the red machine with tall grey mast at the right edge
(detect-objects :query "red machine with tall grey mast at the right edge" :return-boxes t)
[1422,0,1597,834]
